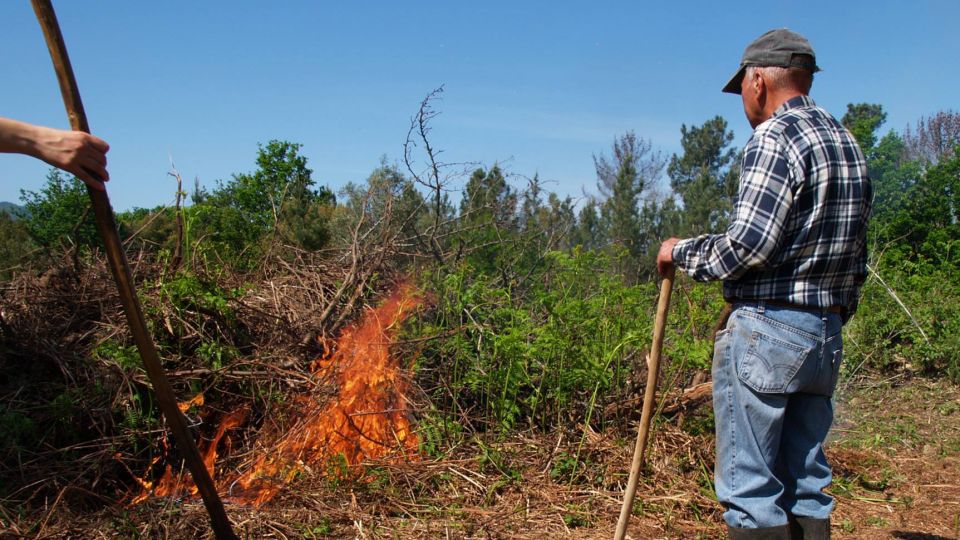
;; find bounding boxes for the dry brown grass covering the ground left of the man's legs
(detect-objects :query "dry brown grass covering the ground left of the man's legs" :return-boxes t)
[0,425,721,539]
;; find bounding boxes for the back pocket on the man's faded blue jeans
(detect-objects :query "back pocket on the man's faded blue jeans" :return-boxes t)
[737,330,813,394]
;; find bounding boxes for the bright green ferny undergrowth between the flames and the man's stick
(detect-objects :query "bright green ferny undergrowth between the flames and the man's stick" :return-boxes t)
[420,250,655,430]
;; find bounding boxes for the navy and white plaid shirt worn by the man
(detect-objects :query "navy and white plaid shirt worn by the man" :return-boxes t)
[673,96,873,317]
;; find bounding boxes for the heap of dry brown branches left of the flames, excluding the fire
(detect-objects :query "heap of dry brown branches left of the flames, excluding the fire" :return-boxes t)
[0,230,404,514]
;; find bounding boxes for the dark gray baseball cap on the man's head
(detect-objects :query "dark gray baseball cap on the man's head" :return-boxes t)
[723,28,820,94]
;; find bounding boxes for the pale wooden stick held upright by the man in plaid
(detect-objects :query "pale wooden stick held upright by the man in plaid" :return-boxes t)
[613,266,676,540]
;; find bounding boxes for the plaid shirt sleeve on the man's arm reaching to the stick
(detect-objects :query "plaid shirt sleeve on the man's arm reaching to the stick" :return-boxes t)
[673,133,793,281]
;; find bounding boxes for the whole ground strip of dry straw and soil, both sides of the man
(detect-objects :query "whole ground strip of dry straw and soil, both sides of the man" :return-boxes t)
[0,376,960,540]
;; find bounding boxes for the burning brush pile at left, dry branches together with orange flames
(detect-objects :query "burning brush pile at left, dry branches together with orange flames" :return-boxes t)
[0,248,442,536]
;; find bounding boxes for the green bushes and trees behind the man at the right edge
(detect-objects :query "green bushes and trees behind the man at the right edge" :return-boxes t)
[847,142,960,382]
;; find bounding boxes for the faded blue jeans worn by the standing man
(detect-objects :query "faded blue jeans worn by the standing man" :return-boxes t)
[713,302,843,528]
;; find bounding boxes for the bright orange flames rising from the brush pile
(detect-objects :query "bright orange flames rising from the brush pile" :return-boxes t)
[133,284,422,507]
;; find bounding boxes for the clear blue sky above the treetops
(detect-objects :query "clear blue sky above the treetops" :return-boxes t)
[0,0,960,210]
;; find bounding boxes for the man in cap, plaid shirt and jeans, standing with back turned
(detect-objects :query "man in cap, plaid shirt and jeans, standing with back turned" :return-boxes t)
[657,29,872,539]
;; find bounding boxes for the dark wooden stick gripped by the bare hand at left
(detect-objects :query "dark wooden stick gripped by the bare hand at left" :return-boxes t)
[31,0,237,540]
